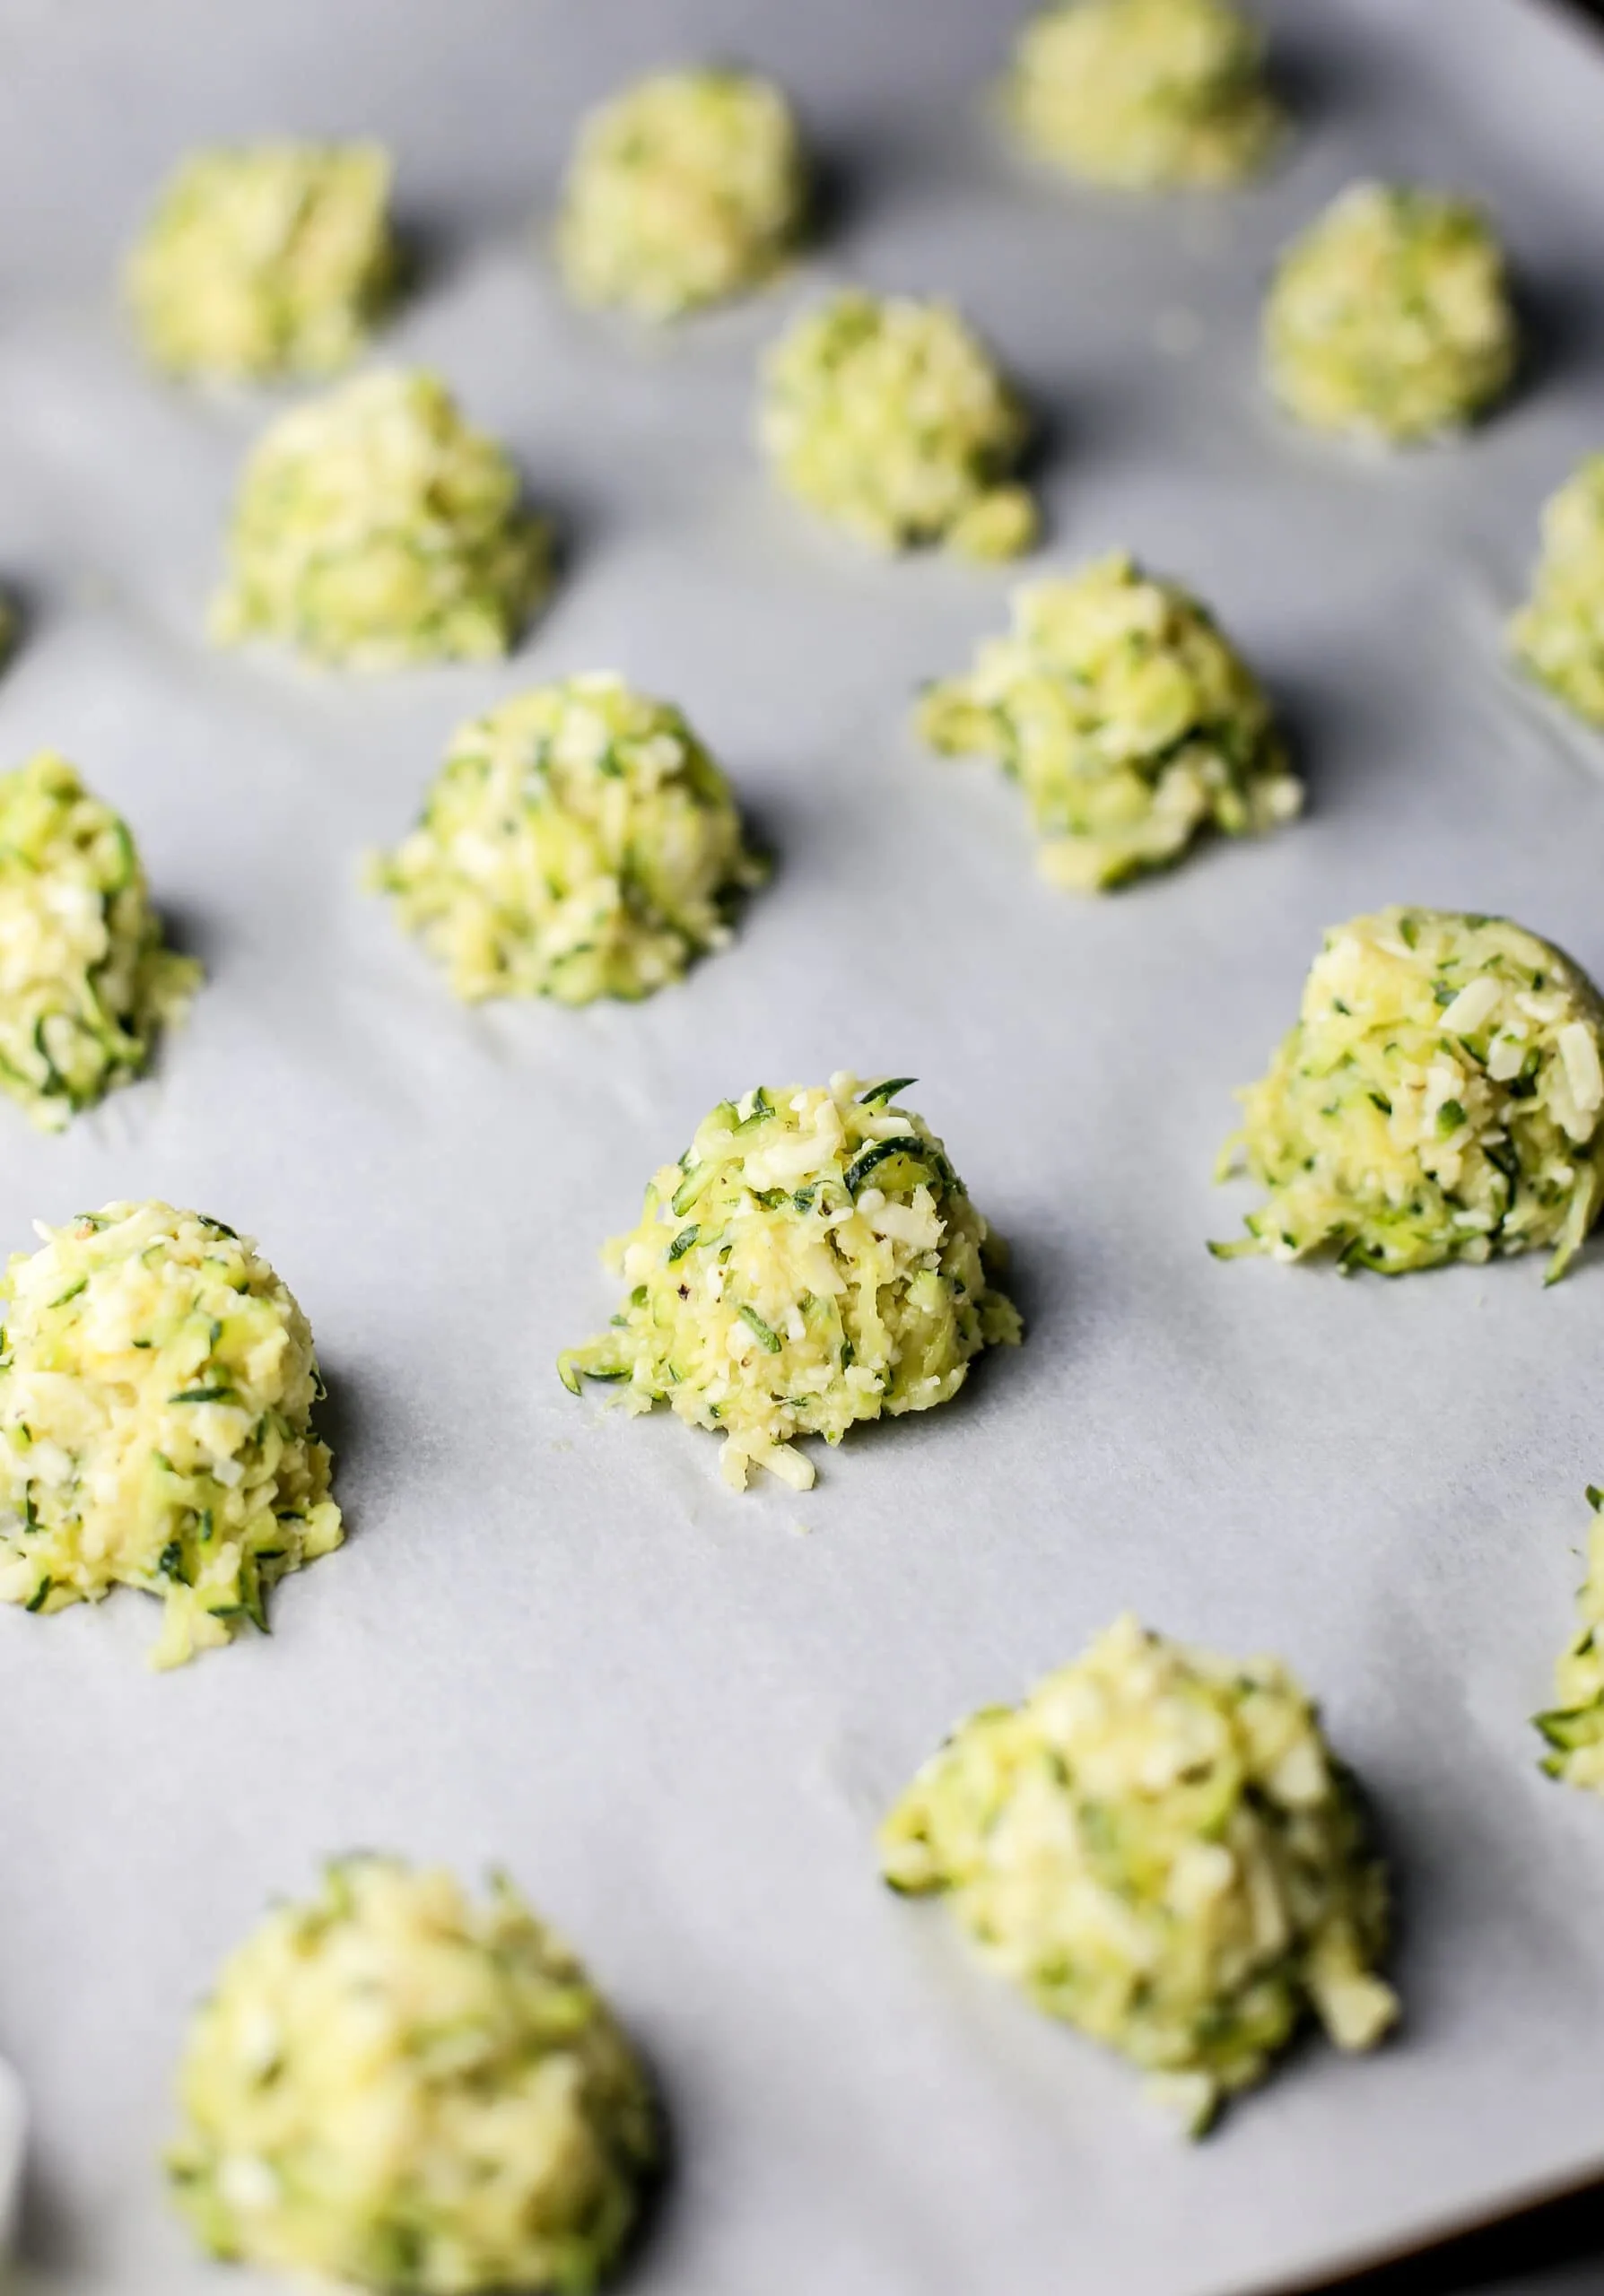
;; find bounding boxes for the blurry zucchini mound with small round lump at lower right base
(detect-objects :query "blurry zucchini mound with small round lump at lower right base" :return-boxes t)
[758,290,1036,558]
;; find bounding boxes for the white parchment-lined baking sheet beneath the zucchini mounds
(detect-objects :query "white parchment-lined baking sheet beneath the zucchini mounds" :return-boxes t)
[0,0,1604,2296]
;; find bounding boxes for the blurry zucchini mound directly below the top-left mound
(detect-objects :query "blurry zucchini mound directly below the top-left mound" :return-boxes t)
[212,372,552,671]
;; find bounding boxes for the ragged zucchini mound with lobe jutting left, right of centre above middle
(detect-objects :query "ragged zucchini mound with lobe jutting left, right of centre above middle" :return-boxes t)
[917,556,1303,893]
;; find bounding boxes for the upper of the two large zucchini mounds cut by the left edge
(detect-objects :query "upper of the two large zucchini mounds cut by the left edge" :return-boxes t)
[0,751,200,1132]
